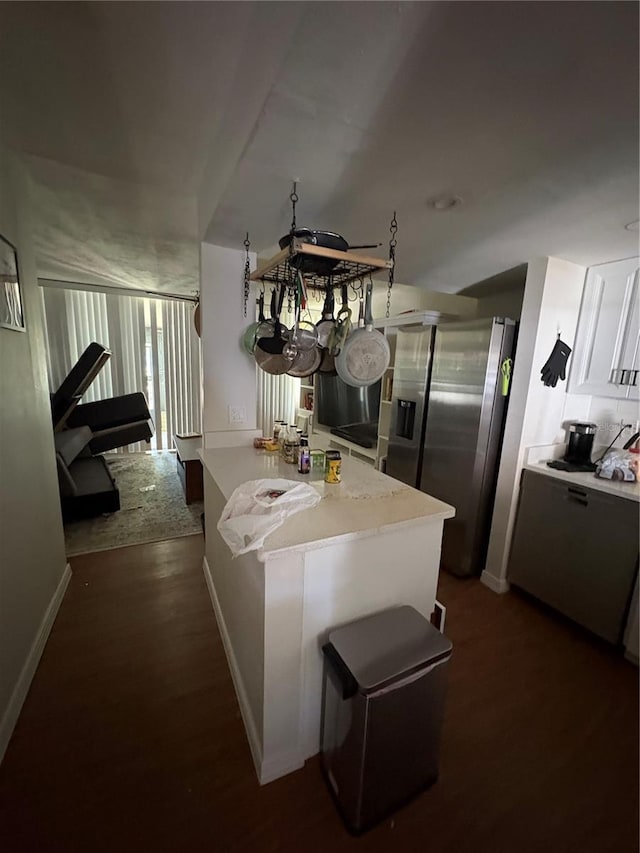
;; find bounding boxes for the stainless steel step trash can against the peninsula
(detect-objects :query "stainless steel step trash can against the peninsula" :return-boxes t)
[322,606,452,832]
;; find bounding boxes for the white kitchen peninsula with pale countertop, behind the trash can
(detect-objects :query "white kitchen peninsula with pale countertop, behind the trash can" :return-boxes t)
[201,448,455,784]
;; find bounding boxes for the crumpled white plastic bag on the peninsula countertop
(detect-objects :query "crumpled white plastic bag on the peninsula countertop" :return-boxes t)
[218,480,321,557]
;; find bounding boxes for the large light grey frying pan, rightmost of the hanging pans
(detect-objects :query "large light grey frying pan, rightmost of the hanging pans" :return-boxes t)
[336,282,391,388]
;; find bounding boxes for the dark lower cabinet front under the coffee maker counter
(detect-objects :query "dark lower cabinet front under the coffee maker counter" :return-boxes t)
[508,471,640,643]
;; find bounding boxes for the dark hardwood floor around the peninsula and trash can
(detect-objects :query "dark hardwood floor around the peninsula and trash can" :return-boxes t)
[0,536,638,853]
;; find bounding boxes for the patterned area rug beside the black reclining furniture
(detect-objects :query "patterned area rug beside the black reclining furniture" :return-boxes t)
[64,450,203,557]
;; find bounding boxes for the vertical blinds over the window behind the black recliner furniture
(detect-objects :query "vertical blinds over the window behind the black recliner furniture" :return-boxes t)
[42,287,201,450]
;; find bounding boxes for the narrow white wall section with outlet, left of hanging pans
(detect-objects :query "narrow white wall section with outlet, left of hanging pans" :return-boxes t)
[200,243,258,447]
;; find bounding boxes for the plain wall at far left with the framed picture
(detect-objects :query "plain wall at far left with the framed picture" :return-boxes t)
[0,149,68,758]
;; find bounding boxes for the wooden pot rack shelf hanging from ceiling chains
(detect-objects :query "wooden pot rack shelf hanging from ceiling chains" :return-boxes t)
[249,239,393,288]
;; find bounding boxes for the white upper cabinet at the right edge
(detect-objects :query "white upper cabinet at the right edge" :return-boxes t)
[568,258,640,400]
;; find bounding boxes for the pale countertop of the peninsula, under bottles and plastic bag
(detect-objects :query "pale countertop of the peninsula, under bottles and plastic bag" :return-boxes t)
[200,447,455,553]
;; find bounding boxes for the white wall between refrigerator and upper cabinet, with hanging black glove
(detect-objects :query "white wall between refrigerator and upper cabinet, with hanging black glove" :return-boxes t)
[482,258,586,592]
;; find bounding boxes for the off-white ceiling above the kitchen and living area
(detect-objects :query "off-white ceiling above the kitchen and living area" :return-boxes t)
[0,2,638,292]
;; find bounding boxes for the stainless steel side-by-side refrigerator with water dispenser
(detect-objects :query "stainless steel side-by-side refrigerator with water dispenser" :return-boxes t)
[386,317,515,577]
